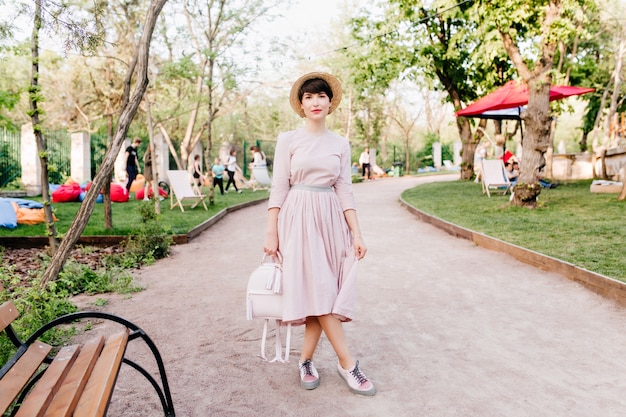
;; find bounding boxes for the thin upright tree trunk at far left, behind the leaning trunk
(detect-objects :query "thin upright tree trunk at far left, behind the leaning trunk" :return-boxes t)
[29,0,57,253]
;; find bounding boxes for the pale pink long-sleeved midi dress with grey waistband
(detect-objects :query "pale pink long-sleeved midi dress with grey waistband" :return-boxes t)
[269,129,357,324]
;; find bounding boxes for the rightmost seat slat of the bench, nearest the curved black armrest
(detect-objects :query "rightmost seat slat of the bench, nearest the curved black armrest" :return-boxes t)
[74,329,128,417]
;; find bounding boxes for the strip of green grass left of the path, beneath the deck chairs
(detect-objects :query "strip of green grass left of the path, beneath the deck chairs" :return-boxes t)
[0,188,269,236]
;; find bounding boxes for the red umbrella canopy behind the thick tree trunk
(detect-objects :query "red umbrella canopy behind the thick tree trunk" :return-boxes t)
[456,80,595,119]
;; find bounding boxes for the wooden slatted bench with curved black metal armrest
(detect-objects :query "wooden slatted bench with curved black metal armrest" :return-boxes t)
[0,286,175,417]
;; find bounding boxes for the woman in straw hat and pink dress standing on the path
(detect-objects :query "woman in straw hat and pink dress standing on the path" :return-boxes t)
[264,72,376,395]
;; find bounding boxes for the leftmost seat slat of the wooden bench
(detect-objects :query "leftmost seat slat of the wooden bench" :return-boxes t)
[0,342,52,413]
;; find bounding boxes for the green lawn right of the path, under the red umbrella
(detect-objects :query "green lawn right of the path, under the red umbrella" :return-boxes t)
[402,180,626,282]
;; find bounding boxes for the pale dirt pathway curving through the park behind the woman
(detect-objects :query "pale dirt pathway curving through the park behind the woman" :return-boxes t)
[88,177,626,417]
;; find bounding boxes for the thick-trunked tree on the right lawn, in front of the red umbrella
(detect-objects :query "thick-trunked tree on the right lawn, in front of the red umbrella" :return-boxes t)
[477,0,586,208]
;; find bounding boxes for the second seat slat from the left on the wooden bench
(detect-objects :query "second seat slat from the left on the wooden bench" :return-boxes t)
[15,345,80,417]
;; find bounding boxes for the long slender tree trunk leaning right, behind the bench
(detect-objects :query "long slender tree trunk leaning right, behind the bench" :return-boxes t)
[41,0,167,286]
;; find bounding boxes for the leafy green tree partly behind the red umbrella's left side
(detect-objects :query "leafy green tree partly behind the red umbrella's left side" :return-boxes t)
[348,0,511,179]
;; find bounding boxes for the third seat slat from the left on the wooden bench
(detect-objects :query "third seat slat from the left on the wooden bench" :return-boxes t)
[44,336,104,417]
